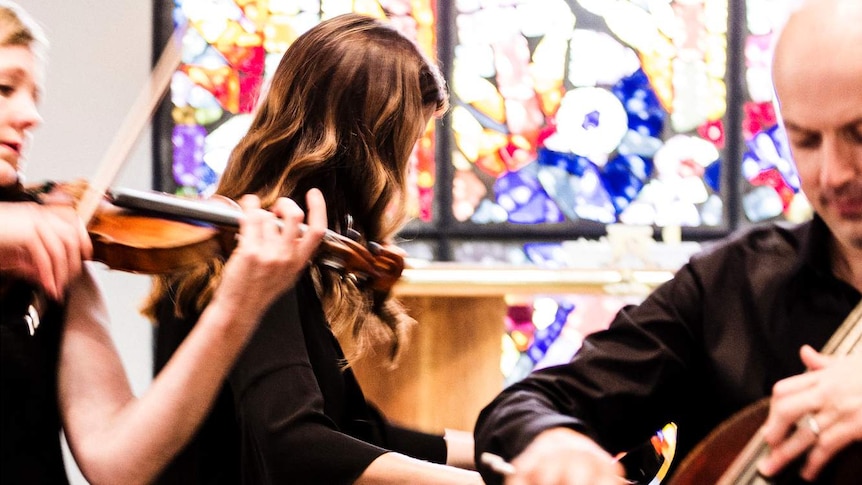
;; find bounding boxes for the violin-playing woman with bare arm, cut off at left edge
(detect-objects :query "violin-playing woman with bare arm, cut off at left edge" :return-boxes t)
[0,0,326,485]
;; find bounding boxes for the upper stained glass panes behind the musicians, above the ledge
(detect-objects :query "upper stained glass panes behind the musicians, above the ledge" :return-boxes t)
[165,0,806,246]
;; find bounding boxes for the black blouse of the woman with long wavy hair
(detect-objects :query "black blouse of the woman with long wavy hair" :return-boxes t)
[156,275,446,484]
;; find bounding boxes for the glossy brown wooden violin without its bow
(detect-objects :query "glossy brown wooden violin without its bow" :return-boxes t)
[35,182,404,293]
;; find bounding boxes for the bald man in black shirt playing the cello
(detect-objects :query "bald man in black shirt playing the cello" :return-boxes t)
[475,0,862,485]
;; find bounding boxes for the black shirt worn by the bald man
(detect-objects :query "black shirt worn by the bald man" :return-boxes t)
[475,218,860,483]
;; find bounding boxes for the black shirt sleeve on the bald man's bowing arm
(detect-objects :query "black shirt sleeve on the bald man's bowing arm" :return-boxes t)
[475,266,702,483]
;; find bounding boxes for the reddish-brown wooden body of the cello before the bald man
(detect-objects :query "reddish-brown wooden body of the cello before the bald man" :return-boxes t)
[668,399,862,485]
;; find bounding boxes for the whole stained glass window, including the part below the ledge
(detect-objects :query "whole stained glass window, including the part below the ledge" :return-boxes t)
[155,0,810,381]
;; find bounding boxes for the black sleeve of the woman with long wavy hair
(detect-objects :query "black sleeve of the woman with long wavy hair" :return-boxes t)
[229,291,387,484]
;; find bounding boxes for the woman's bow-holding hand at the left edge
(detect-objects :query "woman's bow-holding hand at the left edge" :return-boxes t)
[0,202,93,300]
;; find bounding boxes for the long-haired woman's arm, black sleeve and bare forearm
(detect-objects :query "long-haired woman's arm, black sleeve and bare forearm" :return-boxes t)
[229,280,480,484]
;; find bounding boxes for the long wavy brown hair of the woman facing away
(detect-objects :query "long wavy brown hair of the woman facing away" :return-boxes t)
[145,14,448,361]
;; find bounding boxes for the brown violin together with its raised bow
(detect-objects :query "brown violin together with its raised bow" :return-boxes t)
[0,25,404,335]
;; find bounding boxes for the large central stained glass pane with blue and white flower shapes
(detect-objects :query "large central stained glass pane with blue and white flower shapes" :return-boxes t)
[451,0,728,234]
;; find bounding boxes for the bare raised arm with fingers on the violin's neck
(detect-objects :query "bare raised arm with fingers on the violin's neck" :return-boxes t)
[58,191,326,483]
